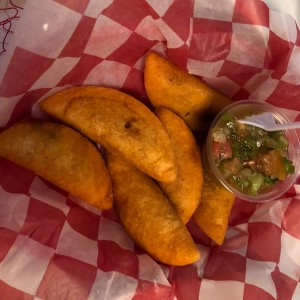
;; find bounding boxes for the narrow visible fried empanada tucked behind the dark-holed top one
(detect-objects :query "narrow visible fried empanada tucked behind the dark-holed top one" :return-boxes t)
[155,107,203,224]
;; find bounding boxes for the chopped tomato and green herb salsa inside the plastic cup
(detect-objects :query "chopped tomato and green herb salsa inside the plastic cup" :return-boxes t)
[211,113,295,196]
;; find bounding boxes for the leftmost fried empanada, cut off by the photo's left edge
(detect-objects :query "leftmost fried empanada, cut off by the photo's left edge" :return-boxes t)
[0,120,113,209]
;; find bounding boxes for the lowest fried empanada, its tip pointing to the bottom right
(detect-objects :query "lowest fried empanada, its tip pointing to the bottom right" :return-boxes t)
[107,154,200,266]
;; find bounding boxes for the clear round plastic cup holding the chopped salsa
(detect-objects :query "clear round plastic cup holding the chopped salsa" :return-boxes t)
[203,100,300,202]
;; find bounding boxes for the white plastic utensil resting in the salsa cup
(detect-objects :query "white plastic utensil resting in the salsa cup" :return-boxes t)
[238,112,300,131]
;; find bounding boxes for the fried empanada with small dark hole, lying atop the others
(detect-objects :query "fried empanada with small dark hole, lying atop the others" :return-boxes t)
[41,86,176,182]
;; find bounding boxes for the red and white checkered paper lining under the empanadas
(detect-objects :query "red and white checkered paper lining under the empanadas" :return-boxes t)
[0,0,300,300]
